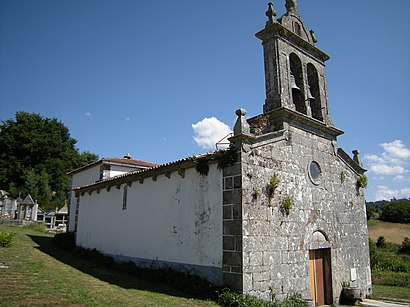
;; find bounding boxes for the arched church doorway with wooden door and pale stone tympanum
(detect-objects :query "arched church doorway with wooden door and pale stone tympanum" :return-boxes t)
[309,231,333,306]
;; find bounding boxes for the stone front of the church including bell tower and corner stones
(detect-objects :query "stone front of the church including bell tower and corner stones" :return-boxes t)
[227,0,371,306]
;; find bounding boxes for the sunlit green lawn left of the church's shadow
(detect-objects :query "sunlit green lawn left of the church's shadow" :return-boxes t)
[0,225,217,306]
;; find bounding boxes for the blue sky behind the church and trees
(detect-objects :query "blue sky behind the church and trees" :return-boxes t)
[0,0,410,200]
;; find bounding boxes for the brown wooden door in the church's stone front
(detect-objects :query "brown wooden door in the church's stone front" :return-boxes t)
[309,249,332,306]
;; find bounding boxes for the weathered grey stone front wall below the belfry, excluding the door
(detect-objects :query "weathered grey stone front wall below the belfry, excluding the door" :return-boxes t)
[241,127,371,303]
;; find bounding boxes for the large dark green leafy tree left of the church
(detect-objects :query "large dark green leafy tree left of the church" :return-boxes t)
[0,112,98,212]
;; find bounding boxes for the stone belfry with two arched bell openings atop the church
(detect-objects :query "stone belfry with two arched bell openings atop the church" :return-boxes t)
[256,0,343,136]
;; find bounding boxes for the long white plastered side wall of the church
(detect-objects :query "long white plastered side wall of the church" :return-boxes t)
[77,164,222,268]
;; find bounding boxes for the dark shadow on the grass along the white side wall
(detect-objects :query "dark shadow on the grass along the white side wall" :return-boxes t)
[27,234,215,300]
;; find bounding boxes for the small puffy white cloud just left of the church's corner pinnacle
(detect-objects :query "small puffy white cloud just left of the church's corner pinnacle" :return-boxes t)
[192,117,232,149]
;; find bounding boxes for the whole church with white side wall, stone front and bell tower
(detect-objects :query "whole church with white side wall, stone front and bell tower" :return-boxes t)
[70,0,371,305]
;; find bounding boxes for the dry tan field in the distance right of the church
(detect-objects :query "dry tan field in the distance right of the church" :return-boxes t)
[368,220,410,244]
